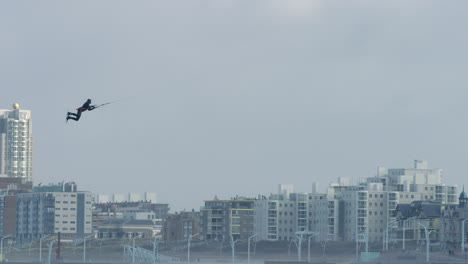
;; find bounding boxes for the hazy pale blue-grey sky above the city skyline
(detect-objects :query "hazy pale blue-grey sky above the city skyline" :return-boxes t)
[0,0,468,211]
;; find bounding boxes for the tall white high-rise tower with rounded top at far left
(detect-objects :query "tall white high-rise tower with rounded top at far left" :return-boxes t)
[0,103,33,181]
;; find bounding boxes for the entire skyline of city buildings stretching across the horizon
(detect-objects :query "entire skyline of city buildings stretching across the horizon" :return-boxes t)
[0,104,468,253]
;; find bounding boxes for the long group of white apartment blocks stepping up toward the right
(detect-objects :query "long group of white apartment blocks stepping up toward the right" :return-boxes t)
[254,160,458,242]
